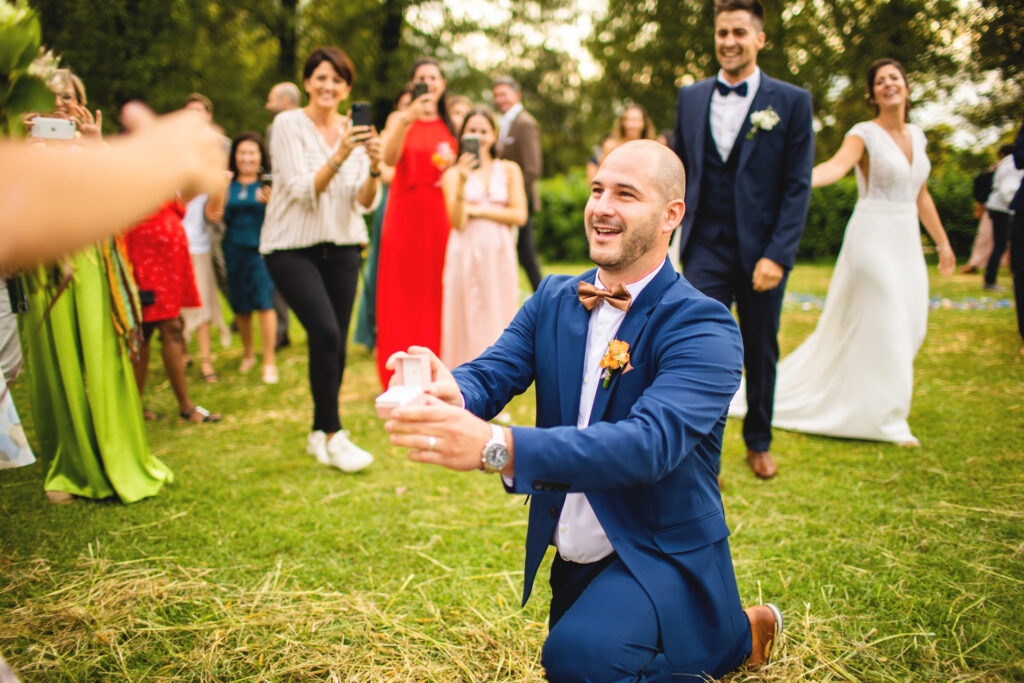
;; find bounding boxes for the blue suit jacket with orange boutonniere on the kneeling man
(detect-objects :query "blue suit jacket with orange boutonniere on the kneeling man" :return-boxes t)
[454,261,749,663]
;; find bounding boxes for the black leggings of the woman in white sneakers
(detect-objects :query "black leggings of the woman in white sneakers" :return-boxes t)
[266,244,362,433]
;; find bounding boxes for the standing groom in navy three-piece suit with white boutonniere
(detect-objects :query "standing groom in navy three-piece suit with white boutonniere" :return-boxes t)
[675,0,814,478]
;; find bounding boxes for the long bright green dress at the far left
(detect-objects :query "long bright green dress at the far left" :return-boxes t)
[18,242,174,503]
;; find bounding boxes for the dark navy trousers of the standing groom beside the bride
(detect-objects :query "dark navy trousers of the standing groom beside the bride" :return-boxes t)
[683,236,790,451]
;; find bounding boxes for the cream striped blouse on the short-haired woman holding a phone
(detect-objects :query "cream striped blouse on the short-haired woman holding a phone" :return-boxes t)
[259,109,381,254]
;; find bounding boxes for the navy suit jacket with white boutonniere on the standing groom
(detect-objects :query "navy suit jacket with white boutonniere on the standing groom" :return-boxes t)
[675,72,814,272]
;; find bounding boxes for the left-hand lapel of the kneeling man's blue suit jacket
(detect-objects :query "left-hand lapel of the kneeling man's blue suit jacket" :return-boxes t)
[555,268,597,425]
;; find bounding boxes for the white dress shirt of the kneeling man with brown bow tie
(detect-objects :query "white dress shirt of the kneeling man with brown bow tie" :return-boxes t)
[554,264,662,564]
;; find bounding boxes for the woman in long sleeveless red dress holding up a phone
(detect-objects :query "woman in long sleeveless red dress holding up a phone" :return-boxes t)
[377,57,457,387]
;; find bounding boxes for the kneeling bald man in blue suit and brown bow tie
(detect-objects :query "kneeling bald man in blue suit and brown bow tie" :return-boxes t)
[385,140,782,681]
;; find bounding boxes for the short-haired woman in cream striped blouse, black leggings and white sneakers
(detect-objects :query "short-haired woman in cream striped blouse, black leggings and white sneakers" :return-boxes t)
[260,47,380,472]
